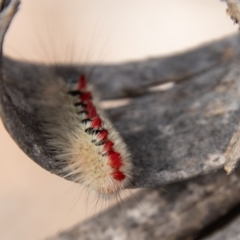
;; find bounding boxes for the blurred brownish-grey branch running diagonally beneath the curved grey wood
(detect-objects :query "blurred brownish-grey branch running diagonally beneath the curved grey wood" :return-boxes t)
[48,170,240,240]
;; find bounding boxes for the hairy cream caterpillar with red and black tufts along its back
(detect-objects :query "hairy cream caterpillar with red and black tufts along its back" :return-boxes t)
[41,74,132,197]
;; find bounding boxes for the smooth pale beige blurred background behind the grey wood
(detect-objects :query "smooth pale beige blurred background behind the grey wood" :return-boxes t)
[0,0,238,240]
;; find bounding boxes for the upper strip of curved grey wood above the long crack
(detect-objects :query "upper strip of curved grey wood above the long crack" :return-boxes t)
[54,33,240,99]
